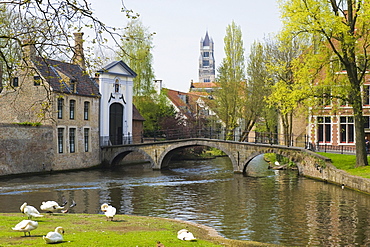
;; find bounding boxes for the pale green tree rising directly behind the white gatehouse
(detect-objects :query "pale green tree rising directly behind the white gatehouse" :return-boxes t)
[118,19,155,96]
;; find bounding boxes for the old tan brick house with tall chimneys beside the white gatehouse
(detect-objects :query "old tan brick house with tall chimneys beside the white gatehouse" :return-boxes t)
[0,33,100,173]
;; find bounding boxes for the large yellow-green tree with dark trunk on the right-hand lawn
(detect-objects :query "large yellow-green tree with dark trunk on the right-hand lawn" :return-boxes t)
[281,0,370,166]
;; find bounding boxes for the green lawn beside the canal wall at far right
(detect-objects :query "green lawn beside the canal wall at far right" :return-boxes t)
[318,152,370,178]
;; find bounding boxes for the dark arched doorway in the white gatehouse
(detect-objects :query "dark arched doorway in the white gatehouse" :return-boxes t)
[109,103,123,145]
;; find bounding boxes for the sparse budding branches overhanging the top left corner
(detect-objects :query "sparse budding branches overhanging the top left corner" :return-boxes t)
[0,0,137,88]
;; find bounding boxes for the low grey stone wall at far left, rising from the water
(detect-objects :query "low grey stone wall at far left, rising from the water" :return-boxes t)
[0,124,54,176]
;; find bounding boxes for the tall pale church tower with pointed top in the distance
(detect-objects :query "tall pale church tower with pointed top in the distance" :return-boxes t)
[199,31,215,82]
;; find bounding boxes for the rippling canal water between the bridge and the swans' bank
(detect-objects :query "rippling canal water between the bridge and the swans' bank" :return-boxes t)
[0,156,370,246]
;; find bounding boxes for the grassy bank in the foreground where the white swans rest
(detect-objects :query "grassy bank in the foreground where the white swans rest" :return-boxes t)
[0,213,273,247]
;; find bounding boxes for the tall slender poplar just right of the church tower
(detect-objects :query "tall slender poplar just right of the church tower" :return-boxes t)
[215,21,245,139]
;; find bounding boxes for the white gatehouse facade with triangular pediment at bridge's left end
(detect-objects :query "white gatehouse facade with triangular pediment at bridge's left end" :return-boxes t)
[98,61,136,146]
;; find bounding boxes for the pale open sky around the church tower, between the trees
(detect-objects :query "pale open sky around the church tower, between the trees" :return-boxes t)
[89,0,282,92]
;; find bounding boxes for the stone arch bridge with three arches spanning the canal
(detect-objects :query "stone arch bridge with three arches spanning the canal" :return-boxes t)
[101,138,330,177]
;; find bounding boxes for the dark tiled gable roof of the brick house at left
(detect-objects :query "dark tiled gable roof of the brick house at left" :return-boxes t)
[33,57,100,97]
